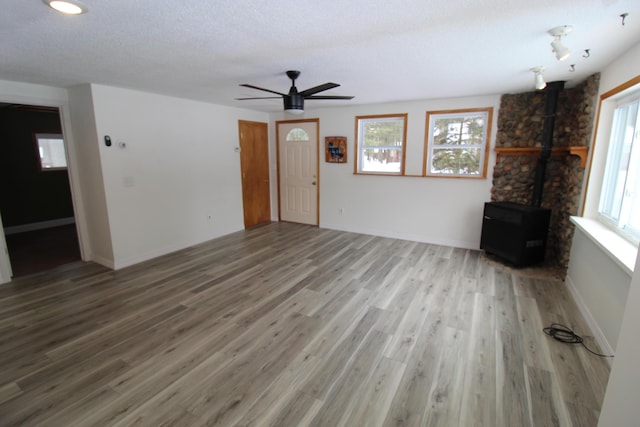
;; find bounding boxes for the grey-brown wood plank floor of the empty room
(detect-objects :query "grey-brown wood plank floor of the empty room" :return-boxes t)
[0,223,609,427]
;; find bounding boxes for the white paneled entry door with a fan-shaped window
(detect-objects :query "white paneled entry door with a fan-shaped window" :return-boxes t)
[277,119,319,225]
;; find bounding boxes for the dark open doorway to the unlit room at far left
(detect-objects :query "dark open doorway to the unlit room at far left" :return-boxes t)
[0,103,81,278]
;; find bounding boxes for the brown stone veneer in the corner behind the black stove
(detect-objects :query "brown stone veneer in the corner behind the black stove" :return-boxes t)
[491,74,600,269]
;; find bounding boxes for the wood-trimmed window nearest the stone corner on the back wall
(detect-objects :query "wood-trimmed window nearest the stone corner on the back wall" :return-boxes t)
[423,108,493,178]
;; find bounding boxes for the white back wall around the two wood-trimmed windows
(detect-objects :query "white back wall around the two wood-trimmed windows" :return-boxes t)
[273,95,500,248]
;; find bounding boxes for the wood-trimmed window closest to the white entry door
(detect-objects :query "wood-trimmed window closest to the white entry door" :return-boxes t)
[355,114,407,175]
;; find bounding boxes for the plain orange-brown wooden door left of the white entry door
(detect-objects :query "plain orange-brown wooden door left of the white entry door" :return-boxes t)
[238,120,271,228]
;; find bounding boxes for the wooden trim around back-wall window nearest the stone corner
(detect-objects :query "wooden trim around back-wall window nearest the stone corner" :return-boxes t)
[422,107,493,179]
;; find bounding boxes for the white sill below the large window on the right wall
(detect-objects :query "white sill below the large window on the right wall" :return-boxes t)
[571,216,638,276]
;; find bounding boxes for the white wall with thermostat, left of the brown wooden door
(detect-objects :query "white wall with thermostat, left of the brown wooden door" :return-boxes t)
[91,84,269,269]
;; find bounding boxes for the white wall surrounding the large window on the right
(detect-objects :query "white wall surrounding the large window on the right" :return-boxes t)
[565,44,640,350]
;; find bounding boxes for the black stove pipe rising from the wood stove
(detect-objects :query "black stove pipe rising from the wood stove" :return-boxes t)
[531,82,564,208]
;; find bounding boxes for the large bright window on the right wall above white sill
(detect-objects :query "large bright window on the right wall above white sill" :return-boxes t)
[598,92,640,242]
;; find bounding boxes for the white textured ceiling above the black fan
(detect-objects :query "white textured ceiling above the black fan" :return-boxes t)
[0,0,640,111]
